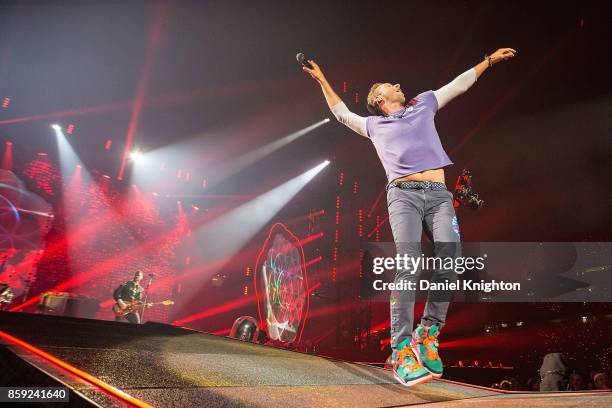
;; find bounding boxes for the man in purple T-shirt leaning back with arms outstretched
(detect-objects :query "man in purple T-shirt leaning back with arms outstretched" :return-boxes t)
[303,48,516,386]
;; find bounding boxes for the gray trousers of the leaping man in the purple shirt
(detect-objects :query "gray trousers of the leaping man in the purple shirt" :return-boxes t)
[387,187,461,349]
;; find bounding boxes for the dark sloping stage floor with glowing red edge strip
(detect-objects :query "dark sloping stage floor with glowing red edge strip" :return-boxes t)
[0,312,612,408]
